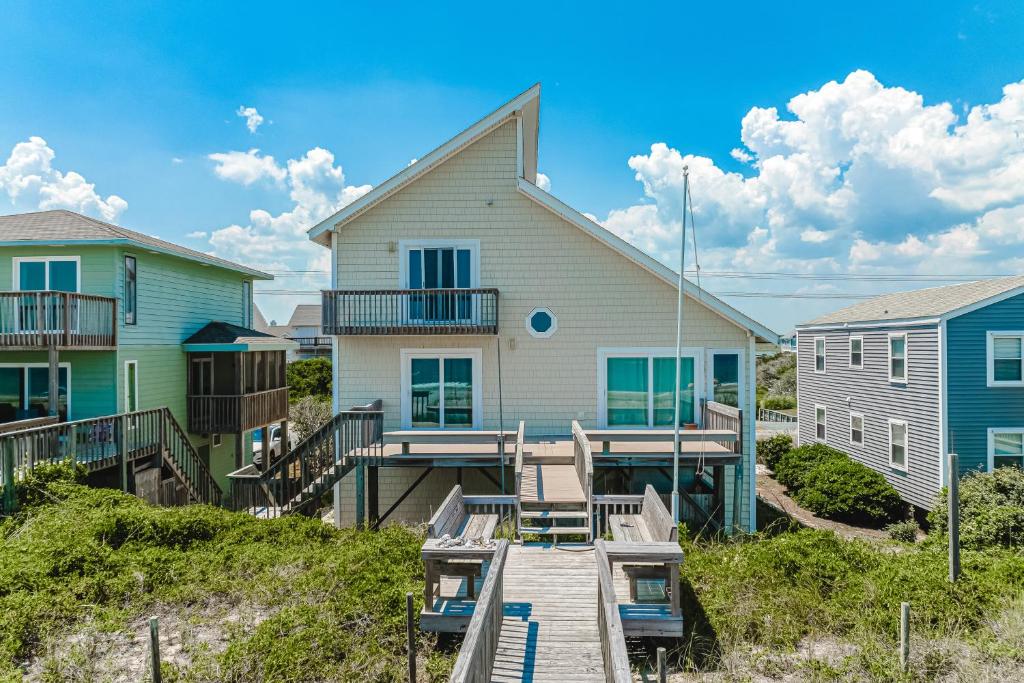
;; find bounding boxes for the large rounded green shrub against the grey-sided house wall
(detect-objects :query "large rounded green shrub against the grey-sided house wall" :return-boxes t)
[794,456,904,525]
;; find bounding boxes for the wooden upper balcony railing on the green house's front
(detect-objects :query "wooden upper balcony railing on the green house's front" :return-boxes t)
[0,292,118,349]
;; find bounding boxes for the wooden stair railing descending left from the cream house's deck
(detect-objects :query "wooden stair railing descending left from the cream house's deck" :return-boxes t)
[227,410,384,517]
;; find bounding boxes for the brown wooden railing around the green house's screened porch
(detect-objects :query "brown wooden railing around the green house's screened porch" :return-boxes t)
[188,387,288,434]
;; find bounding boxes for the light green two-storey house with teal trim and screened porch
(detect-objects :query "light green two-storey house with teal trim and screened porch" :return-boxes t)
[0,210,295,486]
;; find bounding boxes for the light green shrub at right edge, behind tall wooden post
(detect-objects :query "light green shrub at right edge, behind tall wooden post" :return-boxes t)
[928,467,1024,550]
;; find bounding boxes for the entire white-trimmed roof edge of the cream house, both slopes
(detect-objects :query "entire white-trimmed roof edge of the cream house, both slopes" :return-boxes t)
[308,83,778,344]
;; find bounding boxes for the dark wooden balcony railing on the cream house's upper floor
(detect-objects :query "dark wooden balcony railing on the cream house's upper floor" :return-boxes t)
[323,289,498,335]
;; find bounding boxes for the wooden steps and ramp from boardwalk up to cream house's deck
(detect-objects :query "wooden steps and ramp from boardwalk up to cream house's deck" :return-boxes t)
[515,422,594,543]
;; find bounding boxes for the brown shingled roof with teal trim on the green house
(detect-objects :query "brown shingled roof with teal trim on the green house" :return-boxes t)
[0,209,273,280]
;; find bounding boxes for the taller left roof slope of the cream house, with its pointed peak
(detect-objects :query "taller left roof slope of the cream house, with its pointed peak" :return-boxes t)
[308,83,541,247]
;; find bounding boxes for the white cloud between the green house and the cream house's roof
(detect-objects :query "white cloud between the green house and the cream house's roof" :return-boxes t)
[197,142,371,319]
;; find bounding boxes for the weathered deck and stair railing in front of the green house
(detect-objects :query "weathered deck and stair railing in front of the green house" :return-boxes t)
[0,408,221,511]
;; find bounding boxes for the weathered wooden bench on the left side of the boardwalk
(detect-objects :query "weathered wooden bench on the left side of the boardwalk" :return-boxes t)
[424,484,498,606]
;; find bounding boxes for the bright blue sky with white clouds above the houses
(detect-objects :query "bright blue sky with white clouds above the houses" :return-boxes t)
[0,2,1024,332]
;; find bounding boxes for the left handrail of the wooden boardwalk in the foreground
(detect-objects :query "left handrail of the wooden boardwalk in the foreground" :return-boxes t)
[449,539,509,683]
